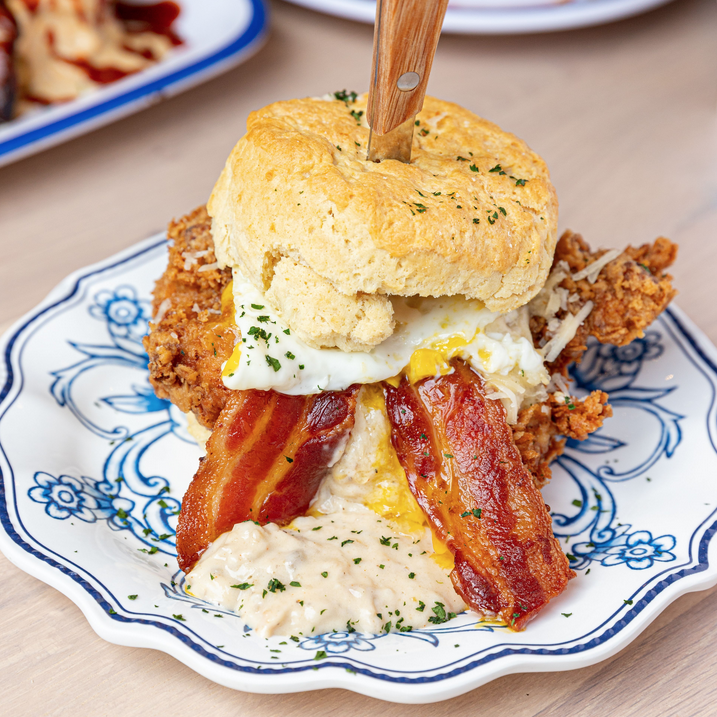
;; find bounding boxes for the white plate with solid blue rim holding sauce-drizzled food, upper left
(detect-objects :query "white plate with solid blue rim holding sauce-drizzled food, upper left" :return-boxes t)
[0,0,268,167]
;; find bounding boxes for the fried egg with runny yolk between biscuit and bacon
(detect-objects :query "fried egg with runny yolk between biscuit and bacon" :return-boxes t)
[222,269,548,395]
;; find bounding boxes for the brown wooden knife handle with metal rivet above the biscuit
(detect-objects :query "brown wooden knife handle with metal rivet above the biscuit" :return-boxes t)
[367,0,448,135]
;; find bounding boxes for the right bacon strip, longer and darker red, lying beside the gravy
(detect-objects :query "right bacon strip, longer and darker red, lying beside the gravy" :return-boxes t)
[384,359,575,630]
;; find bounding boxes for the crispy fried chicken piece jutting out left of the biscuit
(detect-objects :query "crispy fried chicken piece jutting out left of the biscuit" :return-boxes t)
[144,207,235,428]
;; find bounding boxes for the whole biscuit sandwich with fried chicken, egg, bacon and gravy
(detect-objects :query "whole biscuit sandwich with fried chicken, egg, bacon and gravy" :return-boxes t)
[145,92,676,636]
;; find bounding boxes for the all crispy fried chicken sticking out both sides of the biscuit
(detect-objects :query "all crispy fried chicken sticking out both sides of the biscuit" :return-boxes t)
[144,207,677,487]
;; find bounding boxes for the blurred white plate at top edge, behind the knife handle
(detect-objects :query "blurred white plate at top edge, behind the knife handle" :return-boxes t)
[287,0,672,35]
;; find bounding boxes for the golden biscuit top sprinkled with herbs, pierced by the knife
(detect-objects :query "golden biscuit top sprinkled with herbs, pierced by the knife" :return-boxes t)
[208,96,558,345]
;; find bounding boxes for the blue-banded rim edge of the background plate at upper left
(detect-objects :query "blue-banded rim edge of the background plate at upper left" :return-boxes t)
[0,0,270,167]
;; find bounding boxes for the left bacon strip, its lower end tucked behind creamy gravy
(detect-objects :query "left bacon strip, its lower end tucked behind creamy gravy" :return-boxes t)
[177,387,358,572]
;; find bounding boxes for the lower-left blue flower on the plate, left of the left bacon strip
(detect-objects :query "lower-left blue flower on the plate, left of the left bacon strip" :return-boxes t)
[28,471,111,523]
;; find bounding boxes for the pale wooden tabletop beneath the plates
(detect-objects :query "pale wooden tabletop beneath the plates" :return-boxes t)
[0,0,717,717]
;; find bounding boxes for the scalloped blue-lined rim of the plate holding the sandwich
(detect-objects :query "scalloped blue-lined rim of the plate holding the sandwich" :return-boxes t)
[0,232,717,703]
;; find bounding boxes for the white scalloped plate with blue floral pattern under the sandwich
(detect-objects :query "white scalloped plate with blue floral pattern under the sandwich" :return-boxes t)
[0,235,717,703]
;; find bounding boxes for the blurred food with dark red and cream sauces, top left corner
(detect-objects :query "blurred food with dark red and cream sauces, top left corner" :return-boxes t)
[0,0,181,121]
